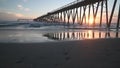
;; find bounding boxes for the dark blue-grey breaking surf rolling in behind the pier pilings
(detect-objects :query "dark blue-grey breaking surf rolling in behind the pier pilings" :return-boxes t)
[0,21,116,29]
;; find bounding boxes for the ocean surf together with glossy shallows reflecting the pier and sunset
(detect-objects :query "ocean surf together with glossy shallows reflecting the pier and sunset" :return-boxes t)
[0,21,120,43]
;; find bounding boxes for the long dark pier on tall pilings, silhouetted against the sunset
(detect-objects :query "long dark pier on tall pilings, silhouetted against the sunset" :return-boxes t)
[34,0,120,30]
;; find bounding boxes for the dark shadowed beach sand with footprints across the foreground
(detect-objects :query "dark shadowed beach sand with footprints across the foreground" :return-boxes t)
[0,39,120,68]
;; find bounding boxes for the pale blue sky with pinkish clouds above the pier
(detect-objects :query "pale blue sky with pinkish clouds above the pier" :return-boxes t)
[0,0,120,20]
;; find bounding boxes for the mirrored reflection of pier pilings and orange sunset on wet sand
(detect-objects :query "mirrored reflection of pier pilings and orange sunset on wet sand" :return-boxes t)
[44,30,120,40]
